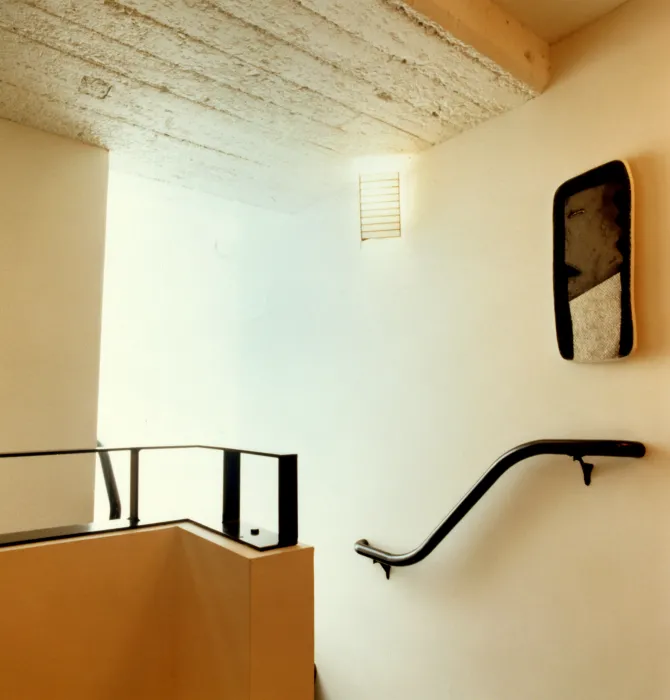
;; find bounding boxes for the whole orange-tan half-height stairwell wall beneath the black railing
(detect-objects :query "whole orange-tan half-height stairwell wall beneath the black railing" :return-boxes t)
[0,524,314,700]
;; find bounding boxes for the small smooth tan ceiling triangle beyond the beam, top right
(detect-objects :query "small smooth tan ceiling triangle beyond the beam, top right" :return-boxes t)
[495,0,627,44]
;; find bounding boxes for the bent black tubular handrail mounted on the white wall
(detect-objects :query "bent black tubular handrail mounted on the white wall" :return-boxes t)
[354,440,646,579]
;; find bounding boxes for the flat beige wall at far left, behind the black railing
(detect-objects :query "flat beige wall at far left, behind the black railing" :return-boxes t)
[0,121,107,532]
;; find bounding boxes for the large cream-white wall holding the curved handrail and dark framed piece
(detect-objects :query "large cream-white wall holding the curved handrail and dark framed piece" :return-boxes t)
[101,0,670,700]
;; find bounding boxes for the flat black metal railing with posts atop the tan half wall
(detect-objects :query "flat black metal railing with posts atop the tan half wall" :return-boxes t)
[0,443,298,551]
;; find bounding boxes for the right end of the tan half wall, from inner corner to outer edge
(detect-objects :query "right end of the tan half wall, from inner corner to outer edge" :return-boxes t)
[178,530,314,700]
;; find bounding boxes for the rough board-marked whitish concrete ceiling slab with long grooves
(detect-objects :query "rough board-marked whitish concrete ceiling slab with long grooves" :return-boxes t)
[0,0,534,210]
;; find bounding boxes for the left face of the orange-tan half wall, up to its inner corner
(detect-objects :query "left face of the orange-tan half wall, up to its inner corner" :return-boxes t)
[0,530,177,700]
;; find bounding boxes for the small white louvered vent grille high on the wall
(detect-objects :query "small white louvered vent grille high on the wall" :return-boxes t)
[359,173,400,241]
